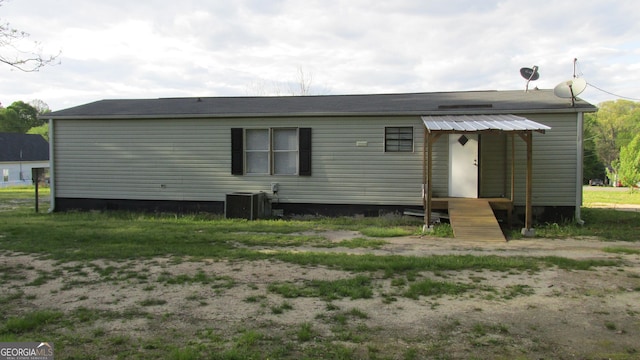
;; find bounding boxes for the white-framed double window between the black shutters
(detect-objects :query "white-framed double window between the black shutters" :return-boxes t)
[245,128,298,175]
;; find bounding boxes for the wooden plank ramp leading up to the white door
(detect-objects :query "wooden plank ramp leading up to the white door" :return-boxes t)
[448,198,506,242]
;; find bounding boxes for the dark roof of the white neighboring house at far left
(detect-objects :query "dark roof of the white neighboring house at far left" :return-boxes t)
[0,133,49,162]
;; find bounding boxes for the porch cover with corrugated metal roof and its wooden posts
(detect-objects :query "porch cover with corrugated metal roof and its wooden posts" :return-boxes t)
[422,114,551,233]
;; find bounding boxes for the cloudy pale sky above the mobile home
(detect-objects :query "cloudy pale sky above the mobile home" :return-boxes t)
[0,0,640,110]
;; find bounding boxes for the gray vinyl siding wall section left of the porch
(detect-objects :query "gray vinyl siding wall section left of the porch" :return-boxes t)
[54,117,436,205]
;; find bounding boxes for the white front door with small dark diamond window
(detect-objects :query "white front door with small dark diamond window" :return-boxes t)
[449,134,478,198]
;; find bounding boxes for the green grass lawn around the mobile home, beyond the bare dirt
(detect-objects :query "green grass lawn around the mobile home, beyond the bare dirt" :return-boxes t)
[0,187,640,253]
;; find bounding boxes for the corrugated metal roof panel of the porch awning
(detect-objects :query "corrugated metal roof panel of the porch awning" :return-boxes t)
[422,114,551,133]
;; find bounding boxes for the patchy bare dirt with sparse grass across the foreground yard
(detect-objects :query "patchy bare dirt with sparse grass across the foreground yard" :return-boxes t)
[0,232,640,359]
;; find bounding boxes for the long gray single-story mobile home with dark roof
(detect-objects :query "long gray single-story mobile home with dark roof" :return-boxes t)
[46,89,596,226]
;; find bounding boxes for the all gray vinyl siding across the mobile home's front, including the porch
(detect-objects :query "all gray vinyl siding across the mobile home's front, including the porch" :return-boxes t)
[53,114,577,206]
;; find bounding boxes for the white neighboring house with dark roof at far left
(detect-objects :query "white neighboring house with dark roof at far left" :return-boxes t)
[0,133,49,187]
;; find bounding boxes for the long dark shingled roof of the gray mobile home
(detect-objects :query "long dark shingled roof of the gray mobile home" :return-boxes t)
[44,90,596,119]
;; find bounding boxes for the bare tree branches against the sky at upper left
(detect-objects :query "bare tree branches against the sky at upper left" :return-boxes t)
[0,0,60,72]
